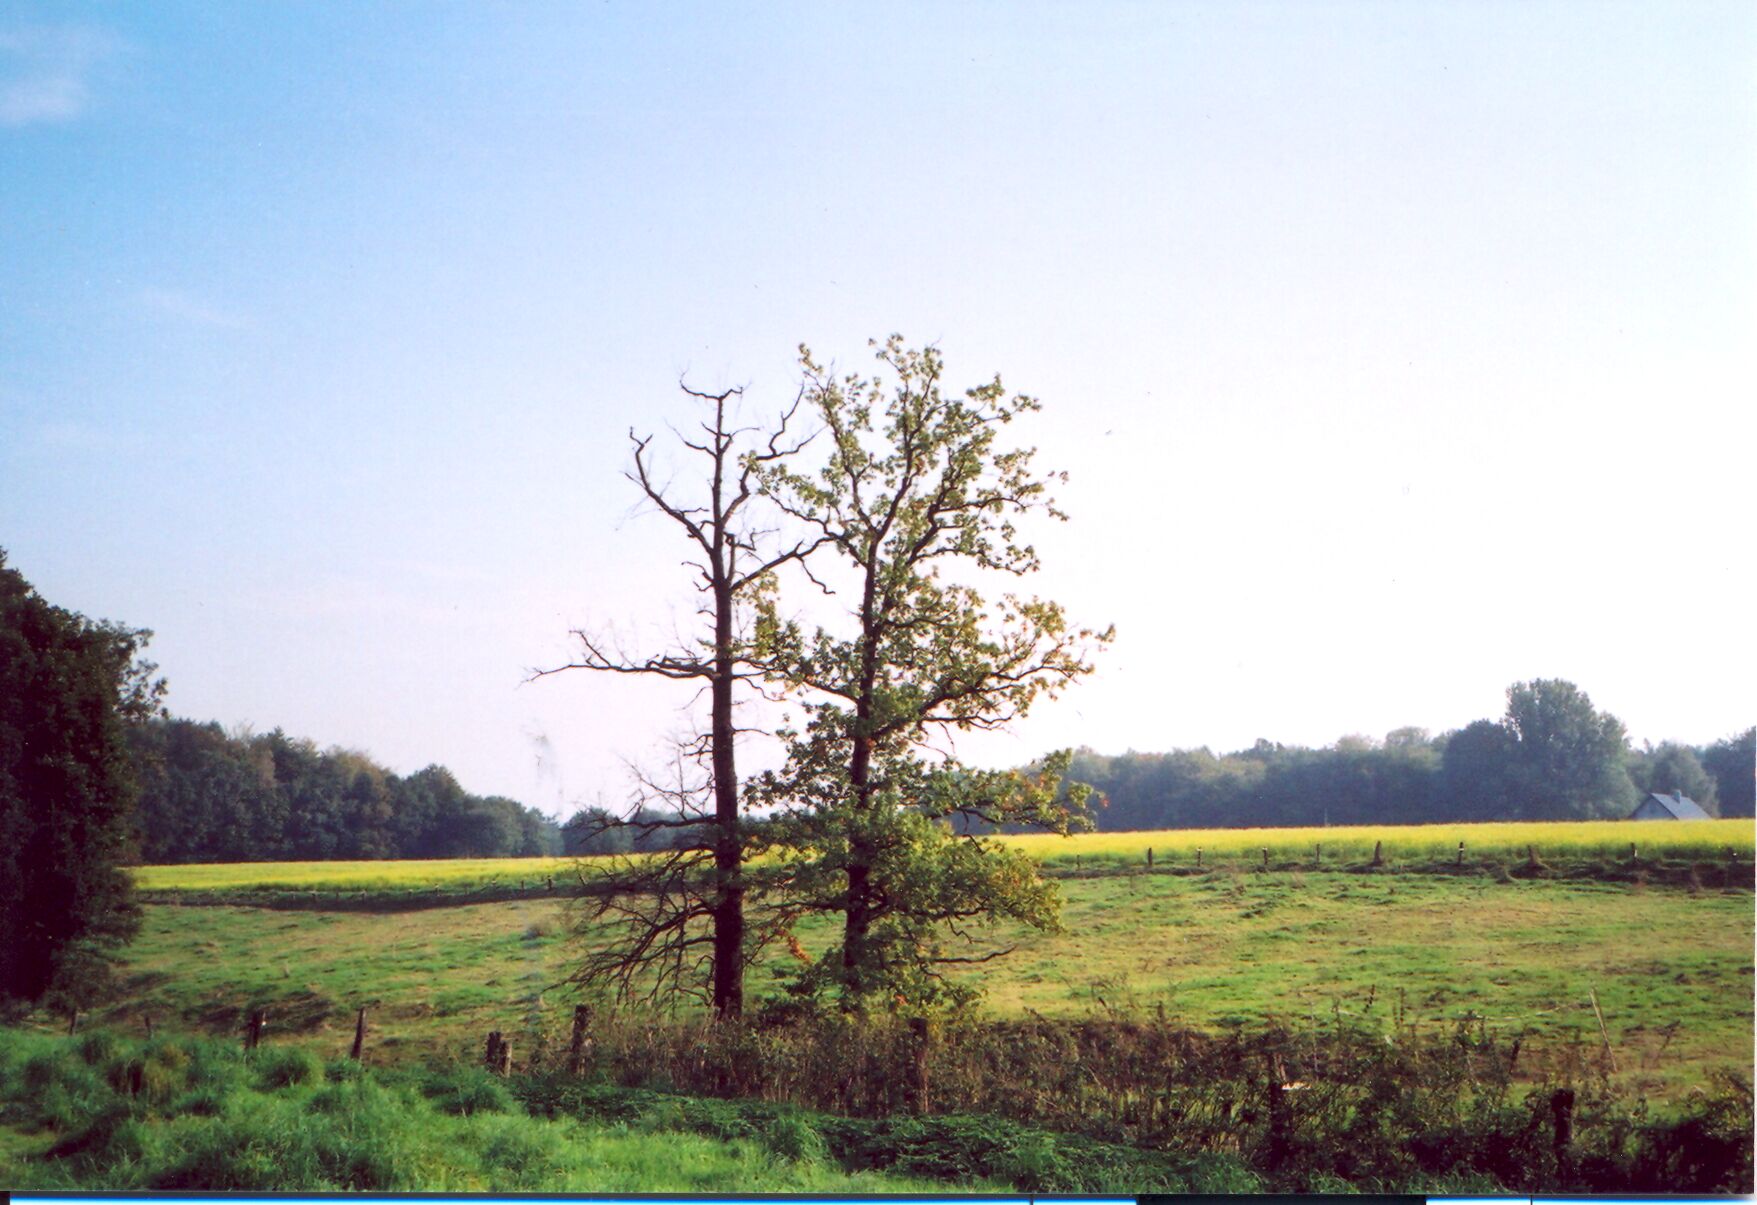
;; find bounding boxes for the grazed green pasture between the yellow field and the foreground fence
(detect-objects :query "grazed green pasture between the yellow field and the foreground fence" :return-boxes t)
[107,871,1753,1096]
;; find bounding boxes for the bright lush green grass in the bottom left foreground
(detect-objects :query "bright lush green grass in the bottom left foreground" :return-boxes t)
[0,1029,1000,1193]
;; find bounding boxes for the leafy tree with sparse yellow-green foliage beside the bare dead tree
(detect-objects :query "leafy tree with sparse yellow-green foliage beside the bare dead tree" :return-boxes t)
[757,336,1109,1007]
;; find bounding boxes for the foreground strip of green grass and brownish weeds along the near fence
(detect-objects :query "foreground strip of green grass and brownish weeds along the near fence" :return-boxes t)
[10,1019,1752,1193]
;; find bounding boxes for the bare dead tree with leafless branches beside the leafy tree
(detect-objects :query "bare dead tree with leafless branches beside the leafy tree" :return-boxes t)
[532,381,824,1017]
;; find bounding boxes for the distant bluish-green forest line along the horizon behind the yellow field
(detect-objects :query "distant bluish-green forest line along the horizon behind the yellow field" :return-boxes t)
[134,718,1757,862]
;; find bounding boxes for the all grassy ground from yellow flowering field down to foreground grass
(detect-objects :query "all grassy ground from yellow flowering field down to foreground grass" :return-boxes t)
[0,820,1753,1191]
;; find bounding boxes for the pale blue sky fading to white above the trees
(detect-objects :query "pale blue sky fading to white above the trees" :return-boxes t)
[0,4,1757,822]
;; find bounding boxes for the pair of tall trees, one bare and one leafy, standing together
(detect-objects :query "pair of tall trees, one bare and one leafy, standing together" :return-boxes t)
[543,336,1110,1017]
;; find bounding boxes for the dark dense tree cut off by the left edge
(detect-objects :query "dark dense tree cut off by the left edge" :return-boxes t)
[0,552,163,1007]
